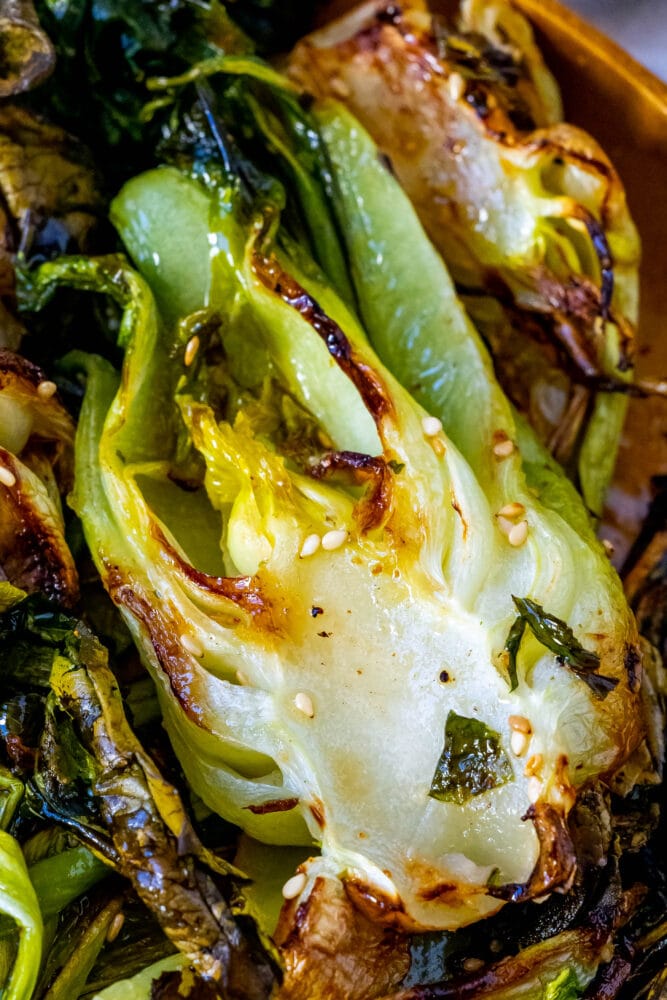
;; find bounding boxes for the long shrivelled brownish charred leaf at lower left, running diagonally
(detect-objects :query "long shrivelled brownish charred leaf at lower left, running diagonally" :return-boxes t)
[0,596,275,1000]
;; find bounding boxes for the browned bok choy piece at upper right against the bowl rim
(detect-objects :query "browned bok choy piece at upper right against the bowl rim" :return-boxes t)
[291,0,639,514]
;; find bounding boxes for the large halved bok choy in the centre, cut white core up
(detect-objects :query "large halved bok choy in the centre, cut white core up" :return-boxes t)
[28,109,644,930]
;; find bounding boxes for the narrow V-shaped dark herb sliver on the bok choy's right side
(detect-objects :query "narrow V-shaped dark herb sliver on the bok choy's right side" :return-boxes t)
[516,597,618,698]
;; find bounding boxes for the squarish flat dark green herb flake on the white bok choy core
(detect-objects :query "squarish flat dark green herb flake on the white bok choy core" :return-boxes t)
[429,712,513,805]
